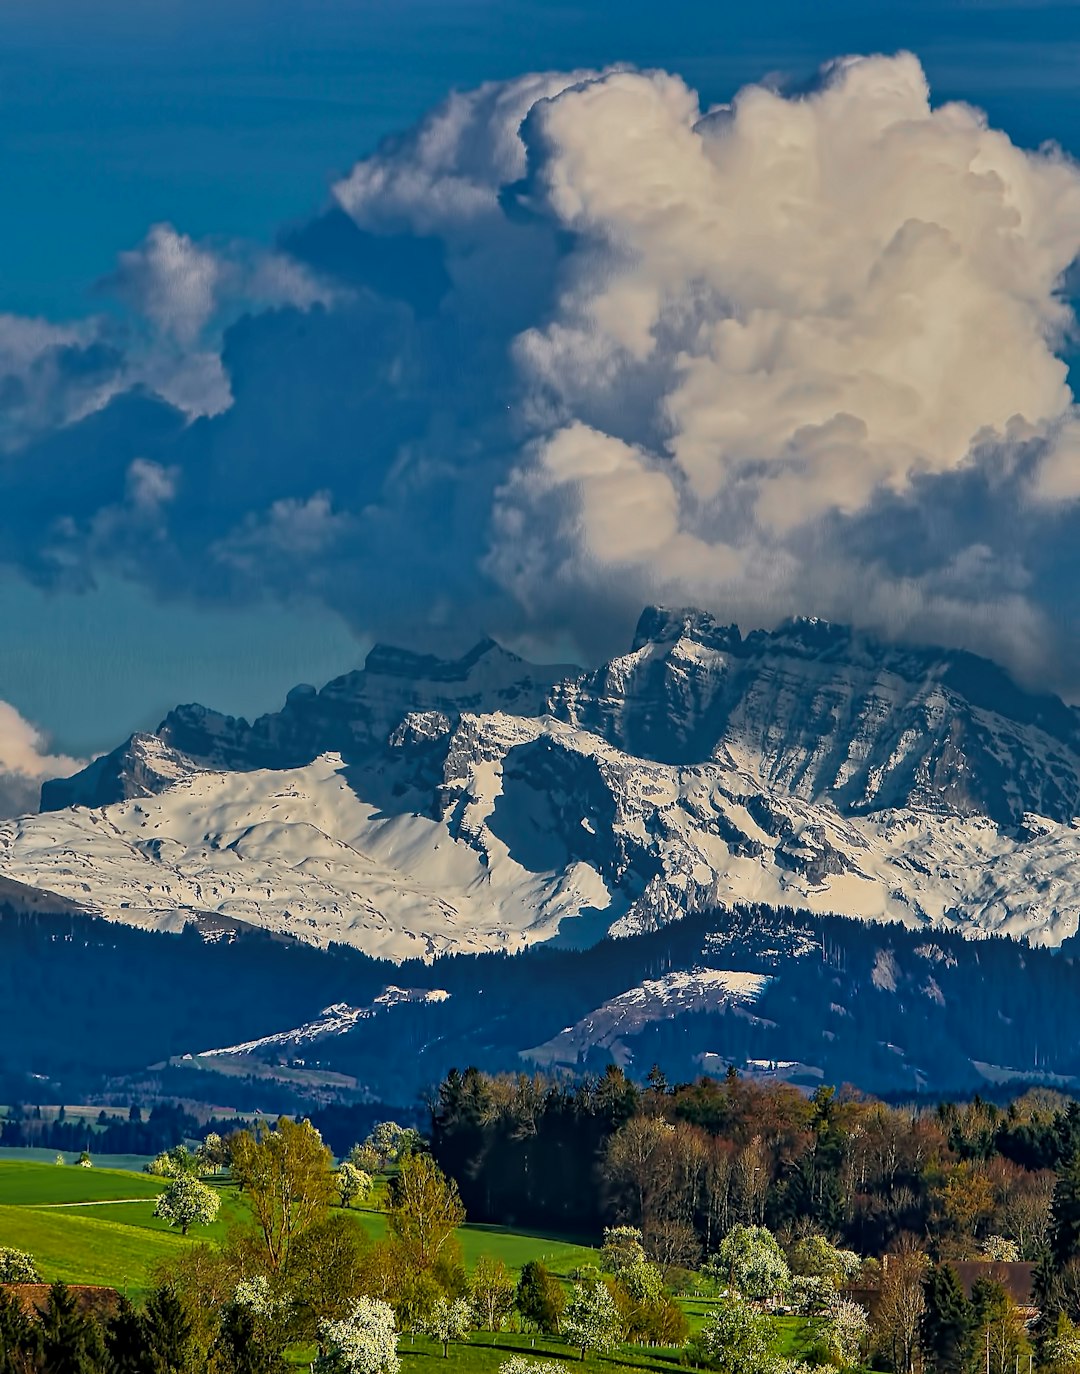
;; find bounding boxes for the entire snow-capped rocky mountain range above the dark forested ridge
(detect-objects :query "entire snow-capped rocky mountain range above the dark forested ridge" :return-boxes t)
[0,609,1080,959]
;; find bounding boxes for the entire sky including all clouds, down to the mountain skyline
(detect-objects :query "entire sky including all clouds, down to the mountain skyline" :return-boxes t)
[0,0,1080,796]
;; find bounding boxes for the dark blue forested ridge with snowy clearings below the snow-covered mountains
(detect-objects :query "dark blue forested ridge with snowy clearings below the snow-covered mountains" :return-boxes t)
[0,907,1080,1109]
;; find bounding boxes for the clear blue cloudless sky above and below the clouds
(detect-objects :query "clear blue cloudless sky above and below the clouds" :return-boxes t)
[0,0,1080,753]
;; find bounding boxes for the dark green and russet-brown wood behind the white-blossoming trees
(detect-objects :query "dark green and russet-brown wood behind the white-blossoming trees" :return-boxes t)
[431,1066,1080,1265]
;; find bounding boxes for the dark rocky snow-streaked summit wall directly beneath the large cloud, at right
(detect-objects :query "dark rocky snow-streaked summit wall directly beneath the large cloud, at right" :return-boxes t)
[551,607,1080,824]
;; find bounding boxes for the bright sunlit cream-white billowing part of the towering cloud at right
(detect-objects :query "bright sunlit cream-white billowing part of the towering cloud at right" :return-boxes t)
[489,55,1080,648]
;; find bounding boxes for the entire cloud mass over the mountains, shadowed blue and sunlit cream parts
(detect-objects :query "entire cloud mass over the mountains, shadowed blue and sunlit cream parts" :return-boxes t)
[0,54,1080,692]
